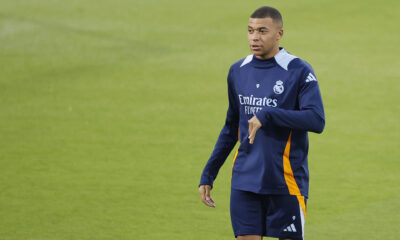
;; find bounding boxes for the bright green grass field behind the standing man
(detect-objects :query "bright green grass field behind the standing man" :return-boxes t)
[0,0,400,240]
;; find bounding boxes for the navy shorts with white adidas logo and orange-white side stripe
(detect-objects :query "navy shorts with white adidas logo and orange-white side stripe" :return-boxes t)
[231,189,306,240]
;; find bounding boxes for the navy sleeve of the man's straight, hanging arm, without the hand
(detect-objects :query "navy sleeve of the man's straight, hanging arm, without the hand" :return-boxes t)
[199,69,239,187]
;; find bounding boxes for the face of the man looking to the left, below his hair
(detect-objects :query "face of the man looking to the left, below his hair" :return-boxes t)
[247,17,283,59]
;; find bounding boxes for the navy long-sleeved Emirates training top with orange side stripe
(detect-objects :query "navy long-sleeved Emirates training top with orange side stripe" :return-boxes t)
[200,48,325,197]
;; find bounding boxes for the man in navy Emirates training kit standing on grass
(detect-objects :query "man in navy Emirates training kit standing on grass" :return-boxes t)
[199,7,325,240]
